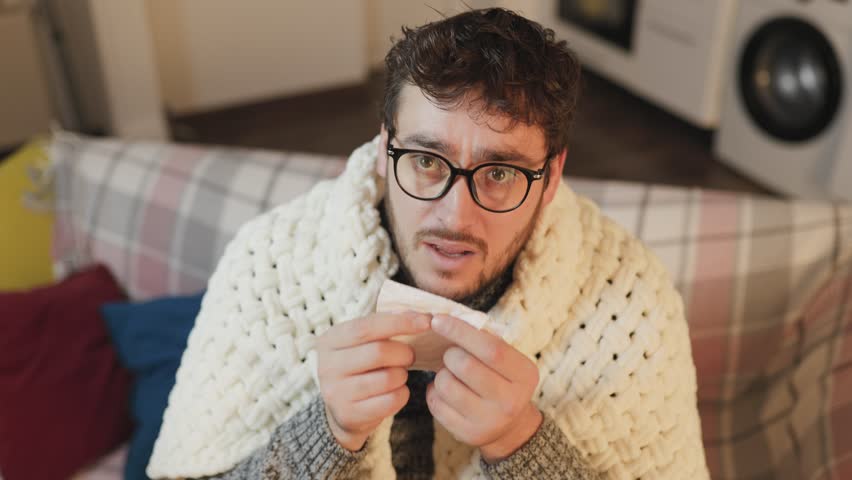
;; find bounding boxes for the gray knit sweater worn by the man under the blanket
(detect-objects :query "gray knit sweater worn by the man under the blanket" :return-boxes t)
[199,371,600,480]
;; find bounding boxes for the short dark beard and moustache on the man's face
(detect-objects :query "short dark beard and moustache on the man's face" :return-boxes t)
[379,180,543,312]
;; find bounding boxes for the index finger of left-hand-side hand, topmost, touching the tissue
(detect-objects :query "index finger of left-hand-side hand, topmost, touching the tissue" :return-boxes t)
[325,312,431,349]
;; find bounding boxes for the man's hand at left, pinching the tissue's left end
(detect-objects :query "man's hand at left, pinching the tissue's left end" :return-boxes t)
[316,312,431,452]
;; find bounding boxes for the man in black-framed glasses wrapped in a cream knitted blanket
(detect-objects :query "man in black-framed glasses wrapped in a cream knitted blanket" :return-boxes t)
[148,9,708,479]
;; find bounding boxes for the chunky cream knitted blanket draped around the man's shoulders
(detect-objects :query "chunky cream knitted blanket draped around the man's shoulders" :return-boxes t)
[147,138,709,480]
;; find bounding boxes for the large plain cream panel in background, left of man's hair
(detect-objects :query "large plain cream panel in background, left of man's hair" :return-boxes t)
[147,0,368,113]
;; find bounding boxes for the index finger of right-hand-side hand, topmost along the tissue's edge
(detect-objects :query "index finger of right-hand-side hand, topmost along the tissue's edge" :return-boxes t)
[432,315,530,383]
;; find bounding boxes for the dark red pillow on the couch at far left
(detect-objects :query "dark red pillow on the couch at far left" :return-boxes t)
[0,265,132,480]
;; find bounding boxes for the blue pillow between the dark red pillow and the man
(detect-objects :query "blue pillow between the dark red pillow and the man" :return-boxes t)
[101,291,204,480]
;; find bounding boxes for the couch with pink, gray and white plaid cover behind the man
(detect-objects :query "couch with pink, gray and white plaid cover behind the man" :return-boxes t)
[0,133,852,480]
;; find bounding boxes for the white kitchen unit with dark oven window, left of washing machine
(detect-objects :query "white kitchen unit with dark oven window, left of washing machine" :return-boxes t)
[520,0,750,128]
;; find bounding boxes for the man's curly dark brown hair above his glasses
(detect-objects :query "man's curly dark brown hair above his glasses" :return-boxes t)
[381,8,580,163]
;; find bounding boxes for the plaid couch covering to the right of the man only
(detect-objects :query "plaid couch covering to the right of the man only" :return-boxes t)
[569,179,852,479]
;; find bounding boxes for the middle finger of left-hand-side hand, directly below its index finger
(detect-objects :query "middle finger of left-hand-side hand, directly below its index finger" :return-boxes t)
[325,340,414,377]
